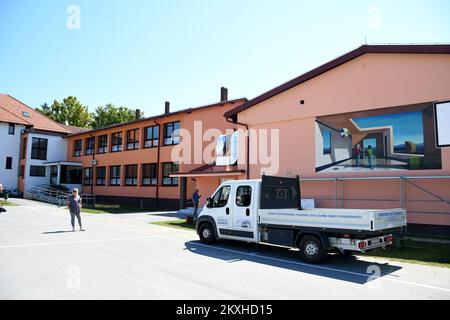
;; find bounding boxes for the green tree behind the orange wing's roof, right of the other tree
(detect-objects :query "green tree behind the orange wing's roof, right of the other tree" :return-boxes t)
[92,103,141,129]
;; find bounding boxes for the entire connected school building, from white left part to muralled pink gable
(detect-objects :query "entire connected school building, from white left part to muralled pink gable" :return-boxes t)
[1,45,450,234]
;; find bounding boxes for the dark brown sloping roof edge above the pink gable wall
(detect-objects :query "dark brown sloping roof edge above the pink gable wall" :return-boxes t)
[224,44,450,118]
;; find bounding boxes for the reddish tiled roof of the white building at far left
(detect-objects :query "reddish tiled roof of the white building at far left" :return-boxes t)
[0,94,70,134]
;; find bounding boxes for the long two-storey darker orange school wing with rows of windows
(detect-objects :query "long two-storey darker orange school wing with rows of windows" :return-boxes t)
[67,88,247,209]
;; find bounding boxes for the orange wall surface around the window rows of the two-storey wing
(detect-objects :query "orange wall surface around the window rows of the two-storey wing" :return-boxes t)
[67,100,244,199]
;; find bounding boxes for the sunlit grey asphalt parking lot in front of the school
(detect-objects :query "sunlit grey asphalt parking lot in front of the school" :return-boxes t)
[0,200,450,300]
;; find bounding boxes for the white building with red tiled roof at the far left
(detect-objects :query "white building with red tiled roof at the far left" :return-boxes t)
[0,94,81,192]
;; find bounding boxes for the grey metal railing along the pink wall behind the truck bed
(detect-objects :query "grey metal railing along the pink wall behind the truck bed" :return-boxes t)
[300,176,450,214]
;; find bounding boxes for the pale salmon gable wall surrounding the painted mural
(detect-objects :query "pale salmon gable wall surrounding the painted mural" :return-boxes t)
[238,54,450,225]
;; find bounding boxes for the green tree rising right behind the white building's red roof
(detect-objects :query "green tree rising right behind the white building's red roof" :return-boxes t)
[36,96,92,128]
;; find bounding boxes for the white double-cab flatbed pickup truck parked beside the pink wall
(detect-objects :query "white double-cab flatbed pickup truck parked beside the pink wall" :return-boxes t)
[196,176,406,263]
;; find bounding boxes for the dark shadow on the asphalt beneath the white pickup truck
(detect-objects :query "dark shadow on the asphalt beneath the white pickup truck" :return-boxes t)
[185,240,401,284]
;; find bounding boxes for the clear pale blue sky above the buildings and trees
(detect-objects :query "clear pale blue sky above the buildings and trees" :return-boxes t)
[0,0,450,116]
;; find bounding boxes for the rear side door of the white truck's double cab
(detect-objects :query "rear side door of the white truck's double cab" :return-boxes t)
[221,183,257,242]
